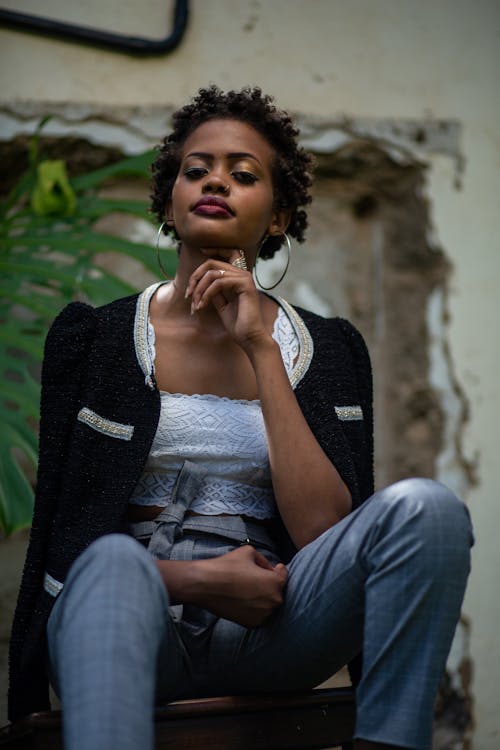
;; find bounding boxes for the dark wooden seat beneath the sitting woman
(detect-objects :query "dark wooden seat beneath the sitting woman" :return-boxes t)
[0,688,355,750]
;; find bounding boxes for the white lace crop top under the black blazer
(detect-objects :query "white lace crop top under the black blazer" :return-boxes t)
[130,307,300,519]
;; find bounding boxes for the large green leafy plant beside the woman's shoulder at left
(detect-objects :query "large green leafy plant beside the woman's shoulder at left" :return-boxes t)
[0,137,163,534]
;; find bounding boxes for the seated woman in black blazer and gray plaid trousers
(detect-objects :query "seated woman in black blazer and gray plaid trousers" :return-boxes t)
[10,87,471,750]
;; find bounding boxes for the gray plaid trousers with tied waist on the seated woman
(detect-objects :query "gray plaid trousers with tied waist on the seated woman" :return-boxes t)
[48,476,472,750]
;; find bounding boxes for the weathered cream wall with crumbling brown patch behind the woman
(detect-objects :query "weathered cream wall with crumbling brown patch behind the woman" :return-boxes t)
[0,0,500,750]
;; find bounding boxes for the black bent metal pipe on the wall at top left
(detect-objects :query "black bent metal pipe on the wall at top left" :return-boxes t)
[0,0,189,56]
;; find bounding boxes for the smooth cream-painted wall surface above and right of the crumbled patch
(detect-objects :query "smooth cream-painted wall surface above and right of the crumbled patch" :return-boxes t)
[0,0,500,750]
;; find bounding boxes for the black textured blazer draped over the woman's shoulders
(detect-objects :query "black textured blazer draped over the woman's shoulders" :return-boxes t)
[9,288,373,721]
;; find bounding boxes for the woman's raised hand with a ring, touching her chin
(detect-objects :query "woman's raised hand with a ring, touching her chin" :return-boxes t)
[186,249,268,348]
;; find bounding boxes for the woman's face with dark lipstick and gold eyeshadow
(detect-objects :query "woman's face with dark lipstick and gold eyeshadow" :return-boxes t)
[166,120,288,265]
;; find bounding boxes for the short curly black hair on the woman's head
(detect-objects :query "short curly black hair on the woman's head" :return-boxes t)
[151,85,314,258]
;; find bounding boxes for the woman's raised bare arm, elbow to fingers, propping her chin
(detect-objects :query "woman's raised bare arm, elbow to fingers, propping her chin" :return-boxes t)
[187,261,351,548]
